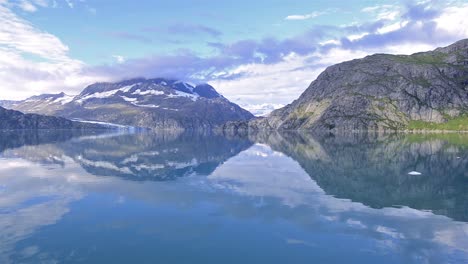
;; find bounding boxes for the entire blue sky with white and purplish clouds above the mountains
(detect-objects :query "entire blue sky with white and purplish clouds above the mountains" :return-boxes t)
[0,0,468,114]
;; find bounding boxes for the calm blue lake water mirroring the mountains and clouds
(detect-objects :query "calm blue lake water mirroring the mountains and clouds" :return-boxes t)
[0,131,468,263]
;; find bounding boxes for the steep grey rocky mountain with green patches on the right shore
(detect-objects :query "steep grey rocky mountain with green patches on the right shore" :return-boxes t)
[224,39,468,131]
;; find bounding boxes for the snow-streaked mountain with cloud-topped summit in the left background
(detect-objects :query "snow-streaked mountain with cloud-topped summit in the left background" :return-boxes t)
[0,78,253,129]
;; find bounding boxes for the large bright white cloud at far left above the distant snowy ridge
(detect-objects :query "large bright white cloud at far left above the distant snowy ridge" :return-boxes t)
[0,5,108,99]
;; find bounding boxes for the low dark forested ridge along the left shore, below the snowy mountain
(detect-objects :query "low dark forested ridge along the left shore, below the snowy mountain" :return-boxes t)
[0,107,103,130]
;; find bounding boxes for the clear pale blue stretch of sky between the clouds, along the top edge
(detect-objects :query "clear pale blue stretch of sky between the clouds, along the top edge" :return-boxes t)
[23,0,370,65]
